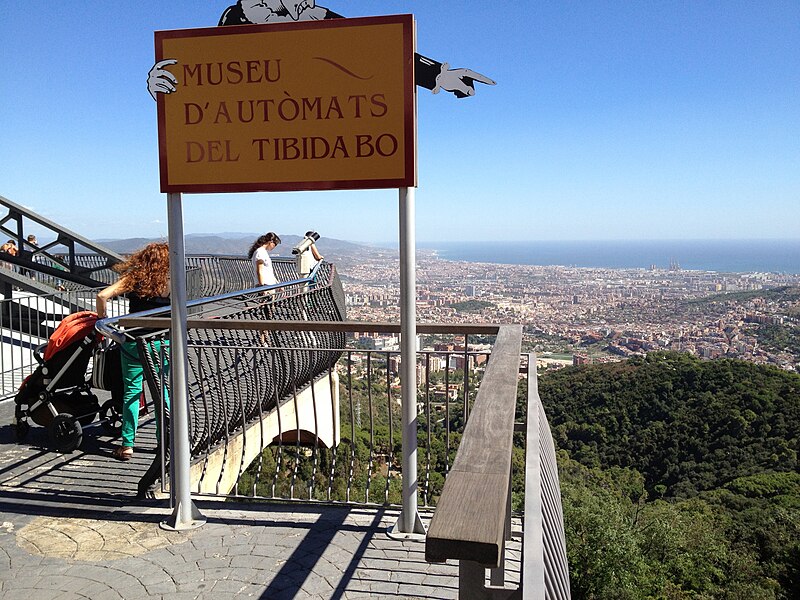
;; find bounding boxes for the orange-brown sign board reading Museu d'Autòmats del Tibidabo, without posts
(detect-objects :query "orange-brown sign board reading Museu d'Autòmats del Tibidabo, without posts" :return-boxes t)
[155,15,416,193]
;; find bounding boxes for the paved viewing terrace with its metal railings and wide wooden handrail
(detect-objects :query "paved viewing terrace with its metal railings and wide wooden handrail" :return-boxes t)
[0,199,569,599]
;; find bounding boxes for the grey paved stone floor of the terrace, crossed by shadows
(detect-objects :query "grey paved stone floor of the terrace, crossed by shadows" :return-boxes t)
[0,402,519,600]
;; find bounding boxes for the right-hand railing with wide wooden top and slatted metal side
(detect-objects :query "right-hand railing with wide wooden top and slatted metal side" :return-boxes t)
[425,342,571,600]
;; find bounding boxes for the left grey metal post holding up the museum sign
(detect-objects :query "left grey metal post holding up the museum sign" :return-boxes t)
[161,193,206,531]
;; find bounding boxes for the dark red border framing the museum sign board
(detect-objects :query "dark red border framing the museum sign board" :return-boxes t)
[155,14,417,194]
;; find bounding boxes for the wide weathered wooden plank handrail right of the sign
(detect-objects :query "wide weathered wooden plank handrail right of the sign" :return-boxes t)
[425,325,522,568]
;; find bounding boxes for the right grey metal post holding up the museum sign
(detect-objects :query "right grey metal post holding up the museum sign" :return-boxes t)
[391,187,425,538]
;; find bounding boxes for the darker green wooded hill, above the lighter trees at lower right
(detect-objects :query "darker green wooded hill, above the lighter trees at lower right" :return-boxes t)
[539,353,800,498]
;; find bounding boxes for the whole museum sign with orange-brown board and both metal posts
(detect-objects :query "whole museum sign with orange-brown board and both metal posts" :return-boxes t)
[153,14,422,536]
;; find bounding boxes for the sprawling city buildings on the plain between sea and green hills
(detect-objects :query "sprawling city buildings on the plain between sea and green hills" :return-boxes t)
[340,251,800,370]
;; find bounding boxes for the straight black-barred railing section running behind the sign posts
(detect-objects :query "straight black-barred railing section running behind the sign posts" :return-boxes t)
[119,318,506,506]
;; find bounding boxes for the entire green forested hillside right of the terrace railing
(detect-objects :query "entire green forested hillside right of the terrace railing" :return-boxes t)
[539,353,800,600]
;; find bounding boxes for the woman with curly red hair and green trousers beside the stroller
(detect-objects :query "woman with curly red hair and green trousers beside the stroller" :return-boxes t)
[96,243,170,460]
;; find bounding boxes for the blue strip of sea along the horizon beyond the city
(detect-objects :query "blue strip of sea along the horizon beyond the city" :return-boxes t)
[417,240,800,274]
